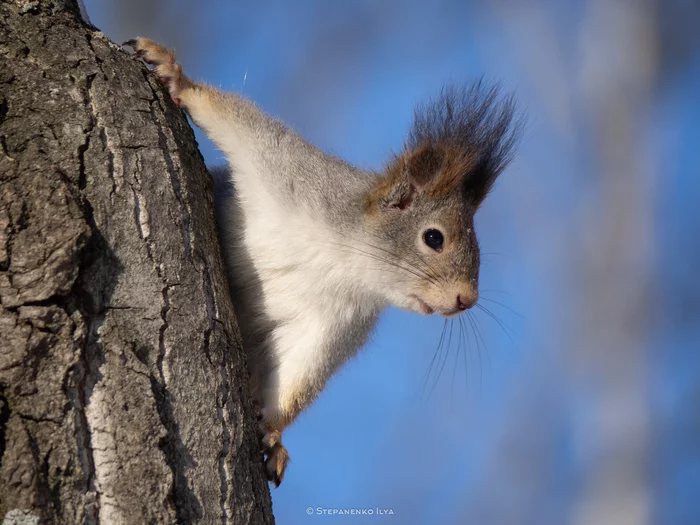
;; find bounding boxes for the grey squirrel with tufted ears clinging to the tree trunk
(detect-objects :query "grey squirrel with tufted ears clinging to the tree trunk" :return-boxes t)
[125,37,519,486]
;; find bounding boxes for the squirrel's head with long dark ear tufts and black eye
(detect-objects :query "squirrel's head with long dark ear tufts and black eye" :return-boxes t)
[364,81,521,317]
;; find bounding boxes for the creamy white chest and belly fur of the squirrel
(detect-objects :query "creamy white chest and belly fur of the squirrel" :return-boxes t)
[228,178,383,407]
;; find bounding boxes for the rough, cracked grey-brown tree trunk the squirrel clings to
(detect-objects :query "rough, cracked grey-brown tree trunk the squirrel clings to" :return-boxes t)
[0,0,273,524]
